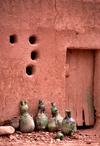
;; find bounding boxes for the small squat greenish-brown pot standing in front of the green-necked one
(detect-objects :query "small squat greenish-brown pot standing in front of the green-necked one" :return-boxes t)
[48,117,58,132]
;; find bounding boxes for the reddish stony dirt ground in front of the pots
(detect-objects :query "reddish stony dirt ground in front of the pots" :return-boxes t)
[0,128,100,146]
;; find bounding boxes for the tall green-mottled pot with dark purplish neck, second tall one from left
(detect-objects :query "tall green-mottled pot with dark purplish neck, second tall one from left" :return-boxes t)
[35,100,48,131]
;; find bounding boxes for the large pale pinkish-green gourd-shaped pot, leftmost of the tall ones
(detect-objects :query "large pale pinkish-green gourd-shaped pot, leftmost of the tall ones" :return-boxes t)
[19,101,35,132]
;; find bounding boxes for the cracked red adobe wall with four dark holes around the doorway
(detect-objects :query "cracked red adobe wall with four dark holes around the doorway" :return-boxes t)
[0,0,100,126]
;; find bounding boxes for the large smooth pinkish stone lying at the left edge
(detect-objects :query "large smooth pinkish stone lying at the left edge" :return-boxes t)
[0,126,15,135]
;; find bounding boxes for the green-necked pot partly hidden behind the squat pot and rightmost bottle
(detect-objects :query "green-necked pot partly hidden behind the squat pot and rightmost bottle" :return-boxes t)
[51,102,63,130]
